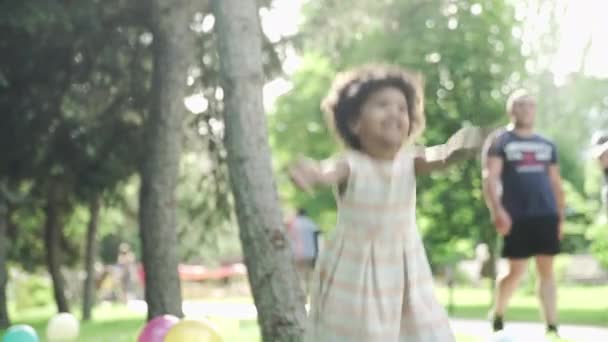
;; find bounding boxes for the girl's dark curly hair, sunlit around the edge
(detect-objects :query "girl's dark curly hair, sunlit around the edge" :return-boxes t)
[321,64,425,150]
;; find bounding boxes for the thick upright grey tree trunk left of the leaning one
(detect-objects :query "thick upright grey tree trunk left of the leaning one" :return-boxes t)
[140,0,194,319]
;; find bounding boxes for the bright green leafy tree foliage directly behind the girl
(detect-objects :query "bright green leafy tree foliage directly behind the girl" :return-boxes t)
[270,1,526,264]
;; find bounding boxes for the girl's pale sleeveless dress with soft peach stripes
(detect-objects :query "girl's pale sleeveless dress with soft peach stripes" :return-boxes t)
[305,146,454,342]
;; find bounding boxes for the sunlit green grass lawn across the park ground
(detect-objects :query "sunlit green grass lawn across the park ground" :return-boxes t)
[0,286,608,342]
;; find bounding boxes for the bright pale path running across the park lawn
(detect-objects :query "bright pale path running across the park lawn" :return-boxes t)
[129,300,608,342]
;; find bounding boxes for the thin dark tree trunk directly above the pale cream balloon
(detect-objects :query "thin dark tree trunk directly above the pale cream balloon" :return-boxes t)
[44,184,70,312]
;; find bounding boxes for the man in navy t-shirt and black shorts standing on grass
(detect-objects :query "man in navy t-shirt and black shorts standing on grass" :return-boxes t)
[483,91,565,334]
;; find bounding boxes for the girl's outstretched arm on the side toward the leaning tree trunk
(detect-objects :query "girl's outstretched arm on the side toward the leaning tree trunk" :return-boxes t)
[288,157,350,192]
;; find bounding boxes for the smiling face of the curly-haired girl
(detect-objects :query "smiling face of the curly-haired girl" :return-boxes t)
[351,87,410,158]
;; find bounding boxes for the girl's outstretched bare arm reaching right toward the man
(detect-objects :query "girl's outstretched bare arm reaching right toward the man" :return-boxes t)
[414,127,489,175]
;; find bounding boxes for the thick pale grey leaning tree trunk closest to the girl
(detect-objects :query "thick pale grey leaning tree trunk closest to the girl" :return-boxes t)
[213,0,305,341]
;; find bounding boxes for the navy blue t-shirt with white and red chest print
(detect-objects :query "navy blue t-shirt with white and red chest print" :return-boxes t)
[488,130,558,220]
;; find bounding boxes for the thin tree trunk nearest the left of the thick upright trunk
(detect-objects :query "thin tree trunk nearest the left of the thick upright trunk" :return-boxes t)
[82,198,100,321]
